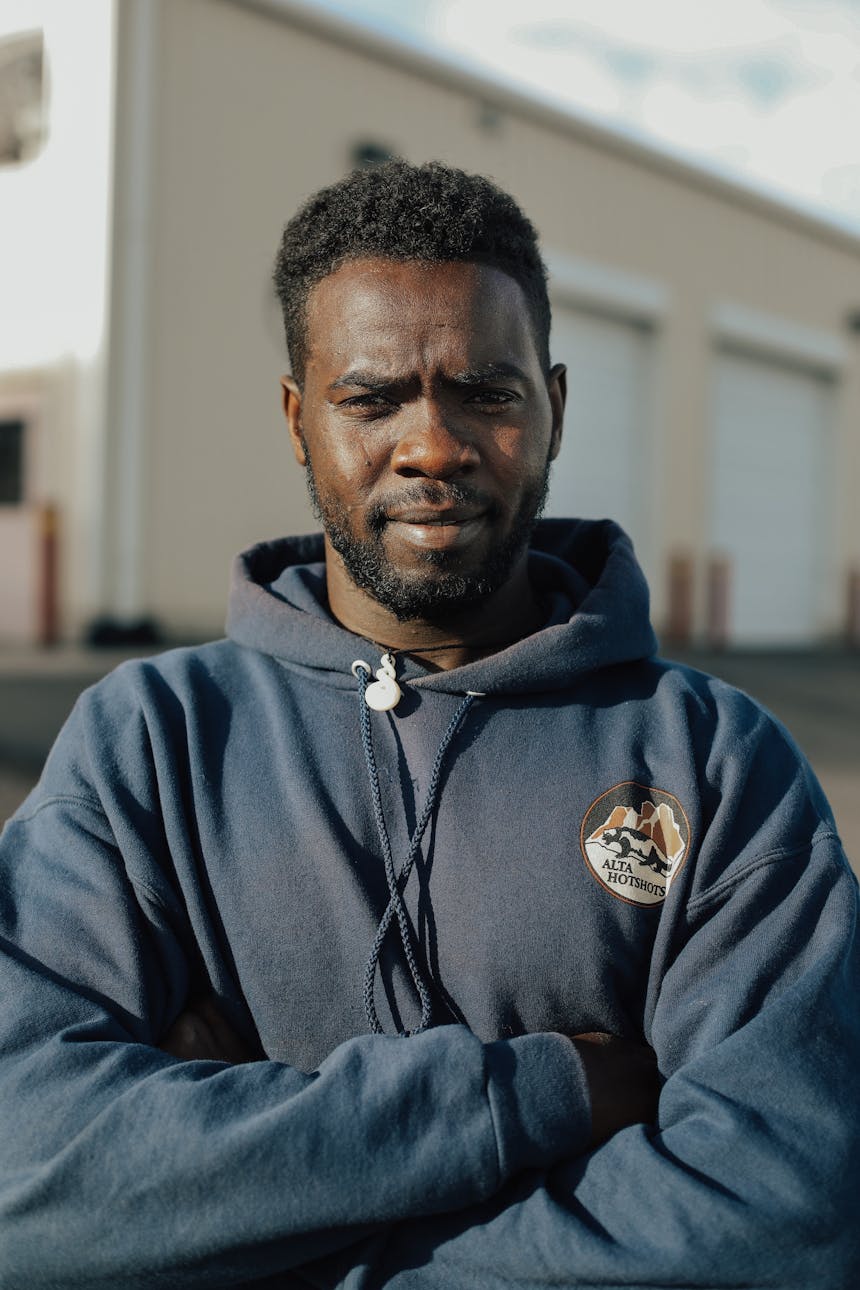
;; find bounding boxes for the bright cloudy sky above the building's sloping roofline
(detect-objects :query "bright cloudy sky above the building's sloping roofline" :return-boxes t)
[306,0,860,233]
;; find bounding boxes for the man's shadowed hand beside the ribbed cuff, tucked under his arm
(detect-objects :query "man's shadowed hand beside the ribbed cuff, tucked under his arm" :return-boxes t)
[572,1031,660,1147]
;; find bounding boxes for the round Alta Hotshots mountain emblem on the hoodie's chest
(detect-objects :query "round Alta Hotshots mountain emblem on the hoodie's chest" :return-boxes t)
[579,780,690,906]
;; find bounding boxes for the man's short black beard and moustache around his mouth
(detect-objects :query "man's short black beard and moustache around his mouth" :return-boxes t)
[304,444,551,622]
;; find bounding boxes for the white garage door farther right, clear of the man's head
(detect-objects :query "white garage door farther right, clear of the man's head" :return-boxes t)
[712,353,830,645]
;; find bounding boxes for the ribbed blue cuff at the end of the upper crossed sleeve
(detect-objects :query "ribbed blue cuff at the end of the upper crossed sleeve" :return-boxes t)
[485,1033,592,1182]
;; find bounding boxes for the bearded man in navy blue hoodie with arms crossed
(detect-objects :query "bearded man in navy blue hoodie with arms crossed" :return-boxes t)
[0,163,860,1290]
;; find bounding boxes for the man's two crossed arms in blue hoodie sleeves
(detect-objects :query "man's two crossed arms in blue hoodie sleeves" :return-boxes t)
[0,743,860,1290]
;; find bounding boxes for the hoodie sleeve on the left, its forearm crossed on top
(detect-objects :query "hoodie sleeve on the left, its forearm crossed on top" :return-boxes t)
[0,710,588,1290]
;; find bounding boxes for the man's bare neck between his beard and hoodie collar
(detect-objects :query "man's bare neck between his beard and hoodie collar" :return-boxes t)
[326,552,543,671]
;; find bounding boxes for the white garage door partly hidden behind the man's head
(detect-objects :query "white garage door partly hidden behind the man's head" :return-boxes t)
[545,303,651,559]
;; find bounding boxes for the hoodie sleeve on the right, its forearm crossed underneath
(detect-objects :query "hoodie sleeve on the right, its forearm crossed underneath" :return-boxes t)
[316,828,860,1290]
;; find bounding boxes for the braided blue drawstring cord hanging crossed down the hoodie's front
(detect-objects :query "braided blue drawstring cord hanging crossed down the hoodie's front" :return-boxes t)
[353,663,476,1037]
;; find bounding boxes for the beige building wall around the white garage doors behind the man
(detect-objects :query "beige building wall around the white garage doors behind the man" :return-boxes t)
[106,0,860,635]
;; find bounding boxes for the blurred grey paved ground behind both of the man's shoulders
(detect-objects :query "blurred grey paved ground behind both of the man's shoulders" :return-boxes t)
[0,649,860,873]
